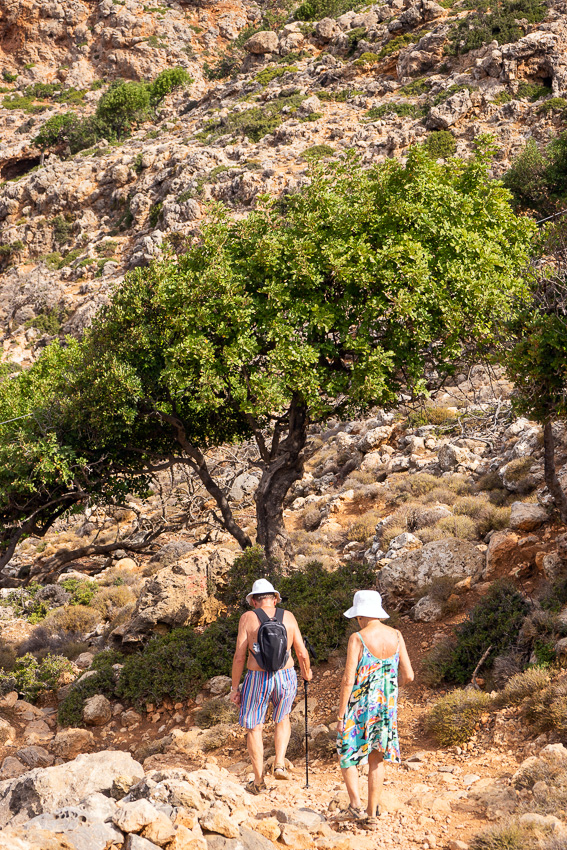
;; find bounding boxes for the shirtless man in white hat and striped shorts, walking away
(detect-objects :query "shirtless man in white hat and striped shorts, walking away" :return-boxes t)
[230,579,313,794]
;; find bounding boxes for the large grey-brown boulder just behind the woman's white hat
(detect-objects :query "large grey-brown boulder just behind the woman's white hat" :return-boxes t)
[377,538,484,600]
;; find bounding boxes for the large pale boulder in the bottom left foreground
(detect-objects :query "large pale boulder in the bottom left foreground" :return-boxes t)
[0,750,144,828]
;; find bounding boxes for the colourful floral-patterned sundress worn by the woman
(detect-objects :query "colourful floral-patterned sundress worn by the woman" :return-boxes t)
[337,632,400,767]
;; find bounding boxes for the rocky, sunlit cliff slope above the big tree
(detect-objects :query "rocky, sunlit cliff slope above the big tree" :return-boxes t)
[0,0,567,365]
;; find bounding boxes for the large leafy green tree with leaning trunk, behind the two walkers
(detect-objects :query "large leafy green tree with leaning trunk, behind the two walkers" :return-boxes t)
[0,149,535,559]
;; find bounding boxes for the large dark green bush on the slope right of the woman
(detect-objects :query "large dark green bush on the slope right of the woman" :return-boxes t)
[426,582,528,685]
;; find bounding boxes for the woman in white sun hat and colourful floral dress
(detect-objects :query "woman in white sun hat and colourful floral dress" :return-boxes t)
[337,590,413,828]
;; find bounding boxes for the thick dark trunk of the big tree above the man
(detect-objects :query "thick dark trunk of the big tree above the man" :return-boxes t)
[255,399,308,566]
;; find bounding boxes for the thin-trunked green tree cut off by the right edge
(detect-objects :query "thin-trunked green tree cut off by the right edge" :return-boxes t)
[507,223,567,523]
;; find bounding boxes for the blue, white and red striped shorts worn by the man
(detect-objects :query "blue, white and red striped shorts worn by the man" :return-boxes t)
[240,667,297,729]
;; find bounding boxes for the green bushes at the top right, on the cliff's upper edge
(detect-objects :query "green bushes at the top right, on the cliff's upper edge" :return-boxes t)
[448,0,547,55]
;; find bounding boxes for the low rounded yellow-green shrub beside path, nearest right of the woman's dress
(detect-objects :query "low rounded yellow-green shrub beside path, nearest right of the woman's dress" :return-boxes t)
[425,689,491,747]
